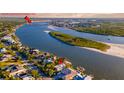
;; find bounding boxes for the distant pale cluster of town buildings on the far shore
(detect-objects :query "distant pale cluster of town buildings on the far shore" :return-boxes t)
[49,18,102,29]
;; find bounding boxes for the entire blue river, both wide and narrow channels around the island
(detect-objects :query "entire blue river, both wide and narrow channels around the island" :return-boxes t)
[16,22,124,79]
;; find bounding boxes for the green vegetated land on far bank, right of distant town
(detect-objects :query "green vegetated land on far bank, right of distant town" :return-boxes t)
[72,23,124,36]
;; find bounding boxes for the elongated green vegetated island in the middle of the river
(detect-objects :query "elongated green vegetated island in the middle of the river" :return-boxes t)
[49,32,110,51]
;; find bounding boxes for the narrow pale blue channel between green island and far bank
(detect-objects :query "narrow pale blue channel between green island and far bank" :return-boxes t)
[50,27,124,44]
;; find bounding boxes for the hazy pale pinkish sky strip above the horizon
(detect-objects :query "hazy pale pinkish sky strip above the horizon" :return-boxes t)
[0,13,124,18]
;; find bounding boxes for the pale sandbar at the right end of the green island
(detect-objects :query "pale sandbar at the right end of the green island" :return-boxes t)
[83,43,124,58]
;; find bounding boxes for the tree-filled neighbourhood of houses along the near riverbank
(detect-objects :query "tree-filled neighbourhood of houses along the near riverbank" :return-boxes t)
[0,21,93,80]
